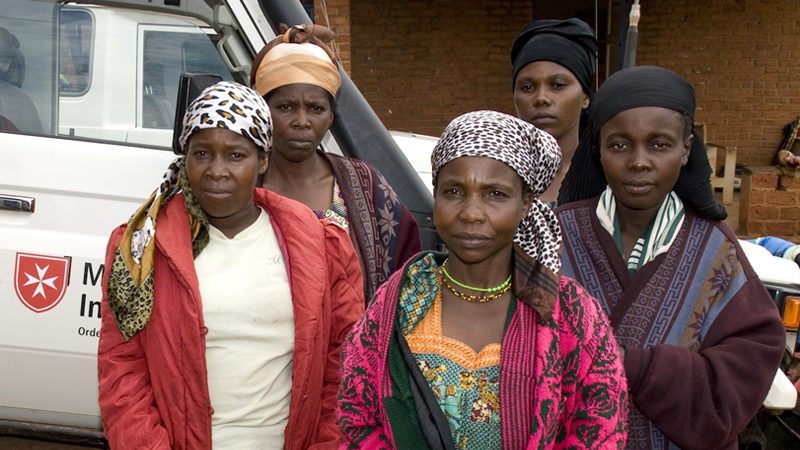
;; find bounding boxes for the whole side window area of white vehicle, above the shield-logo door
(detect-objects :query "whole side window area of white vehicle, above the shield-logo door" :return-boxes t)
[0,0,233,149]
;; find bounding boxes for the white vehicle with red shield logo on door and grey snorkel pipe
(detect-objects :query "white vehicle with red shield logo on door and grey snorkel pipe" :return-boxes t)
[0,0,432,440]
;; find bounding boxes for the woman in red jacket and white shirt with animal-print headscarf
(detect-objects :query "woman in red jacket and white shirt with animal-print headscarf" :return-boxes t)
[98,82,364,449]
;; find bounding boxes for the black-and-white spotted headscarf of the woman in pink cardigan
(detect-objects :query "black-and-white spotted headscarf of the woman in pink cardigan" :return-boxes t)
[431,111,561,276]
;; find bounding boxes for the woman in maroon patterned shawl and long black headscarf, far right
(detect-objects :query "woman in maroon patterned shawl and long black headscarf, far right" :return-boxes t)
[557,66,784,449]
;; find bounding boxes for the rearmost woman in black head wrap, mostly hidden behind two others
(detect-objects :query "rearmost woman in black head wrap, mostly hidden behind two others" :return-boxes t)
[511,18,597,204]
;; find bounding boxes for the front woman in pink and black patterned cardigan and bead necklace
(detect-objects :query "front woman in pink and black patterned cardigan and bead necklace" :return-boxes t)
[337,111,628,450]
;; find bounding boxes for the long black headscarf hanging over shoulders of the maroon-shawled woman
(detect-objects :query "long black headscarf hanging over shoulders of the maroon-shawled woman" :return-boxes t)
[558,66,728,220]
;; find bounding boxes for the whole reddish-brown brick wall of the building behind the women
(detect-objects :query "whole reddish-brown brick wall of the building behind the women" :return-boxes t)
[322,0,800,165]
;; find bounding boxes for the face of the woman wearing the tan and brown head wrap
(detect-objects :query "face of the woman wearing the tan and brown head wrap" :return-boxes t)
[267,84,333,162]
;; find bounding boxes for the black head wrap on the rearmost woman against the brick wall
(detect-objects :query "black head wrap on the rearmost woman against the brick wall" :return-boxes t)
[511,17,597,95]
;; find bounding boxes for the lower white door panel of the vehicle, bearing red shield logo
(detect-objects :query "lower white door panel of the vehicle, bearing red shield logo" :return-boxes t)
[0,134,175,428]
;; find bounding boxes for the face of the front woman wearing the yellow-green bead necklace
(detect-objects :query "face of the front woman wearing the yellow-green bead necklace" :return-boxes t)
[433,156,533,264]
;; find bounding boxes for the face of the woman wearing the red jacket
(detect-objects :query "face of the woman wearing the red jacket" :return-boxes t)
[186,128,267,228]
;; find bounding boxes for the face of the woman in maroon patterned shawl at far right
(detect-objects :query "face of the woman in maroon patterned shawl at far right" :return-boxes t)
[600,106,692,213]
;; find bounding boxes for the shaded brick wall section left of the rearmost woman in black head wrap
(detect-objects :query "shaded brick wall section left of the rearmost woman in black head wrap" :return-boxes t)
[350,0,531,135]
